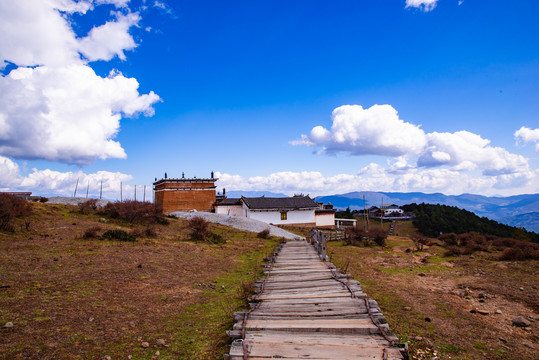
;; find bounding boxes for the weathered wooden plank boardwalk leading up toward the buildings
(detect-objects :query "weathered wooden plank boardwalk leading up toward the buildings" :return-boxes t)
[225,241,405,360]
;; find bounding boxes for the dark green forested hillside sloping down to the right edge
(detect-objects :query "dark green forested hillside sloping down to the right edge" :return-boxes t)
[402,203,539,242]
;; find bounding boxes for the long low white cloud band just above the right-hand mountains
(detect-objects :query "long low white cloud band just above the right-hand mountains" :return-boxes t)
[216,163,539,196]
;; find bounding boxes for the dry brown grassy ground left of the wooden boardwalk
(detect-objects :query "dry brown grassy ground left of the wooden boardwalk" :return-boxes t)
[0,203,273,359]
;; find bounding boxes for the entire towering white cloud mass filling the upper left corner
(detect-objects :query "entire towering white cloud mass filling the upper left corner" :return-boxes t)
[0,0,160,164]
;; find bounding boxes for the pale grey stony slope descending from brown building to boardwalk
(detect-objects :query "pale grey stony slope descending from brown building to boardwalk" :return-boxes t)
[170,211,304,240]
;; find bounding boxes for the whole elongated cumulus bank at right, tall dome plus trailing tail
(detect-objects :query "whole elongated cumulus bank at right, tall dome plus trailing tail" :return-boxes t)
[291,105,539,183]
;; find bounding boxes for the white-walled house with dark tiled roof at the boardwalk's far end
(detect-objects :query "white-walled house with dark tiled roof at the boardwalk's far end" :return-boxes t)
[241,196,318,226]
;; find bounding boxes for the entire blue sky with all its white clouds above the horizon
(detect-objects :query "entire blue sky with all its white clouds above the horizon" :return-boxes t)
[0,0,539,198]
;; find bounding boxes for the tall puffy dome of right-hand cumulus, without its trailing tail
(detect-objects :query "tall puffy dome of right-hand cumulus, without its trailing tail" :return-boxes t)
[292,105,426,156]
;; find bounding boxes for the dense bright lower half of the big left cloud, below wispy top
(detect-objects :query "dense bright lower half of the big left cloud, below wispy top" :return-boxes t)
[0,65,159,164]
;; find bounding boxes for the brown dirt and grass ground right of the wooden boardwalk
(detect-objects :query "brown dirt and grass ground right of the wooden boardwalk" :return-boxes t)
[329,237,539,360]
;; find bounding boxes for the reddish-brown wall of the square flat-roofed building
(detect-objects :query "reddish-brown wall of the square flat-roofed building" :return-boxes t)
[155,189,215,214]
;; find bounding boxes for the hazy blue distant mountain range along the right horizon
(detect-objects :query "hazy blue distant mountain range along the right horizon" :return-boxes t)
[316,191,539,231]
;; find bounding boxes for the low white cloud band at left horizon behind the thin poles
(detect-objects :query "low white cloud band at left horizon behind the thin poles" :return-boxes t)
[0,156,134,200]
